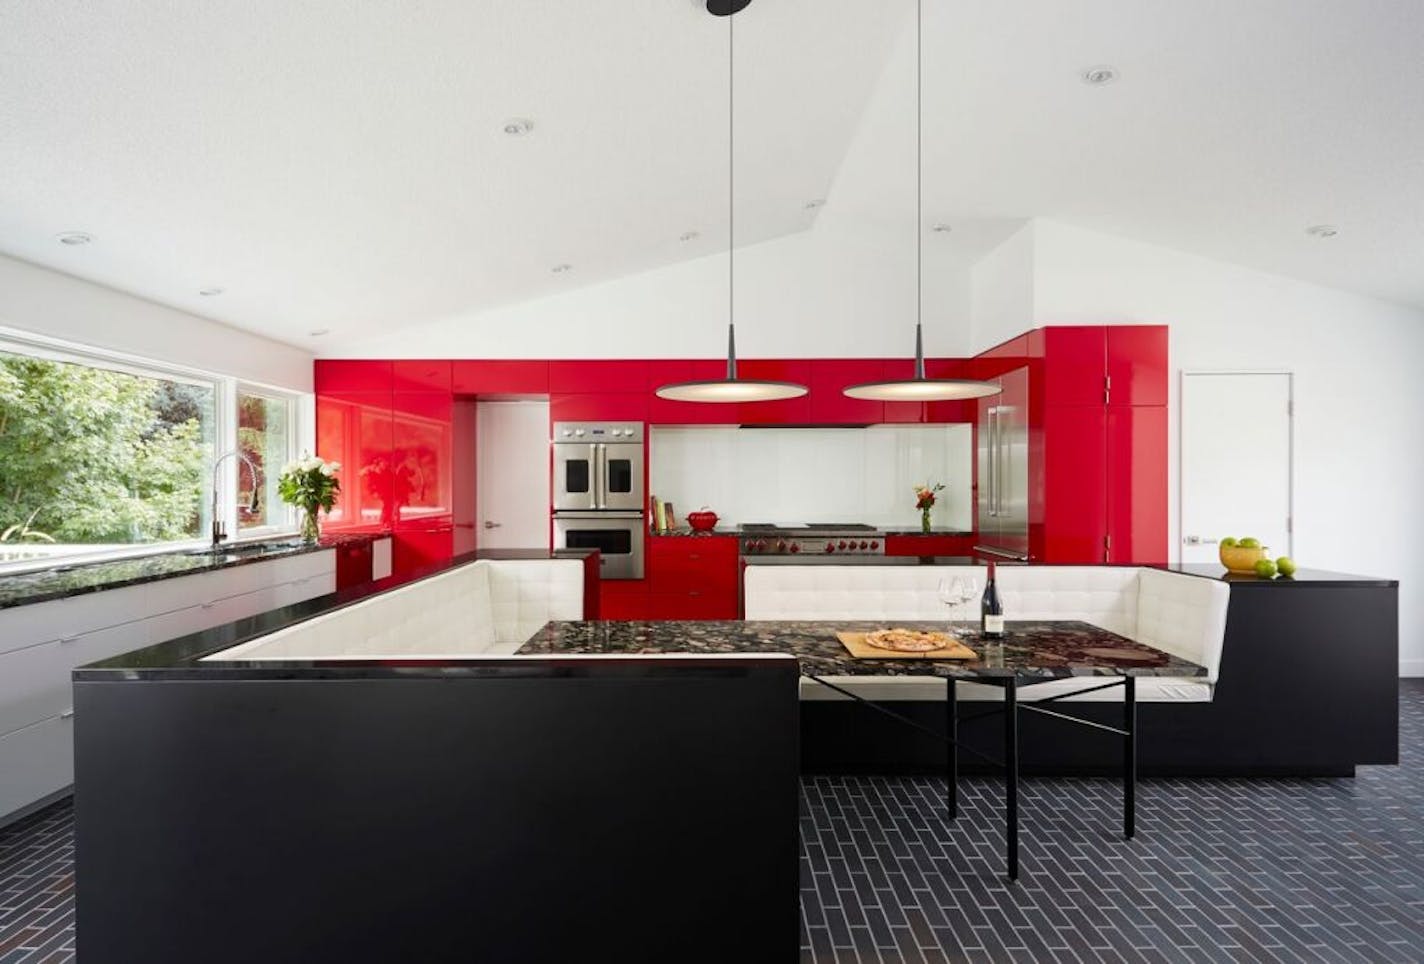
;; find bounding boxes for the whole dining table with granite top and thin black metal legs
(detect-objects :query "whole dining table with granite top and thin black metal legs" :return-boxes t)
[518,619,1206,880]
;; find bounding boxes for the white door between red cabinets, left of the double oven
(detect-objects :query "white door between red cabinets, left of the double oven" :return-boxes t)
[476,402,551,550]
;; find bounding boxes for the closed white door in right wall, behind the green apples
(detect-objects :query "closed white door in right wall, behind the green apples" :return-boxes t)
[1180,372,1292,562]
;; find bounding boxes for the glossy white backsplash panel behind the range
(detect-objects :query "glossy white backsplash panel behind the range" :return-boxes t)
[648,424,974,531]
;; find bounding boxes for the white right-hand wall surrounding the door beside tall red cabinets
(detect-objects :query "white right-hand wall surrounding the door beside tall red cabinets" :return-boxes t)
[974,221,1424,675]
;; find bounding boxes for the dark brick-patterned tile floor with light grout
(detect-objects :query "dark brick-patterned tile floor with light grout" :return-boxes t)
[0,681,1424,964]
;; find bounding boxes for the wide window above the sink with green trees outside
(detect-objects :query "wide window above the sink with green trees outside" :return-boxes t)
[0,332,298,570]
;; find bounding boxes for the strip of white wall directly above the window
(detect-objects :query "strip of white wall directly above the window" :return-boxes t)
[0,255,312,392]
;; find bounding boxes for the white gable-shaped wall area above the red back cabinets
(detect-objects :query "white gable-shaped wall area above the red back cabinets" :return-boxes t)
[339,215,970,359]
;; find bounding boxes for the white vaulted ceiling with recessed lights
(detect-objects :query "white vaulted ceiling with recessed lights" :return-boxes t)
[0,0,1424,347]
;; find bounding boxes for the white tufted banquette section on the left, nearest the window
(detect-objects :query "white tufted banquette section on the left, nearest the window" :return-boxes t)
[208,560,584,659]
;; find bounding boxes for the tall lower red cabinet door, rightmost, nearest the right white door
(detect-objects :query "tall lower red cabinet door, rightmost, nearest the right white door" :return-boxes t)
[1106,406,1168,564]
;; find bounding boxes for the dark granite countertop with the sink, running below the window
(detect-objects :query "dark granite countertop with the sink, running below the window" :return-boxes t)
[0,538,339,609]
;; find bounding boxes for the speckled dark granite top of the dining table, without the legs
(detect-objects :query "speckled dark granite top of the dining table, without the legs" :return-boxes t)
[518,619,1206,679]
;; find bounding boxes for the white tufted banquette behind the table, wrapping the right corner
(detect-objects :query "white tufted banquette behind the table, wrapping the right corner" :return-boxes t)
[745,565,1230,702]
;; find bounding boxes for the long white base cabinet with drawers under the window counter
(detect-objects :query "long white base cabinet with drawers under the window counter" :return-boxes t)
[0,550,336,824]
